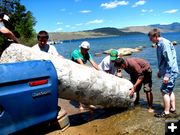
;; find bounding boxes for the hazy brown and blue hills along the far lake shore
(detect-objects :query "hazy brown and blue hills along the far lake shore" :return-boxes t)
[49,22,180,41]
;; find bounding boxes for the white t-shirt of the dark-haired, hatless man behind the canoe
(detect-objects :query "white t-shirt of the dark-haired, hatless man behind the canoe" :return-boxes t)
[32,44,59,56]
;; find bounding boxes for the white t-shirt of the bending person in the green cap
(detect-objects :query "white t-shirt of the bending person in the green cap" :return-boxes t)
[98,55,117,75]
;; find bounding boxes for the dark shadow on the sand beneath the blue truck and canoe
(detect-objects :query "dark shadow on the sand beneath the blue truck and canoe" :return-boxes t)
[12,108,127,135]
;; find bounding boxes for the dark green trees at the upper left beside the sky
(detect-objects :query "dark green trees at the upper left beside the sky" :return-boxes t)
[0,0,36,46]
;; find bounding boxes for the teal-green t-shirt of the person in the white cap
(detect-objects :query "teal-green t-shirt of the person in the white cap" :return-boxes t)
[71,49,92,64]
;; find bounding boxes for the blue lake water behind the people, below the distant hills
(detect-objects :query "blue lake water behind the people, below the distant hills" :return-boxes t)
[55,33,180,90]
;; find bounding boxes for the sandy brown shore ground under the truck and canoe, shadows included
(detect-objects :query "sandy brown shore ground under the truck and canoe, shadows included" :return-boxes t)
[15,99,180,135]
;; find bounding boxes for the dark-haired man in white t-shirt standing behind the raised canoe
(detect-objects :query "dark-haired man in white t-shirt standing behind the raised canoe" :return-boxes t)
[32,30,60,56]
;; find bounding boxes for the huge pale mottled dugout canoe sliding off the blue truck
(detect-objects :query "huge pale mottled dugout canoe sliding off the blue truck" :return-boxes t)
[0,43,134,107]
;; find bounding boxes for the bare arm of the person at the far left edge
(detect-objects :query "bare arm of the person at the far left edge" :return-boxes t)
[0,27,19,43]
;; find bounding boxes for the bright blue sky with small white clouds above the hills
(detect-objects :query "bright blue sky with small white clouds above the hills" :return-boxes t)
[21,0,180,32]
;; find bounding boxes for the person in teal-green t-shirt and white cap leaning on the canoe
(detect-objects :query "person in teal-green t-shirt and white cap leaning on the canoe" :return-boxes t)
[71,41,99,70]
